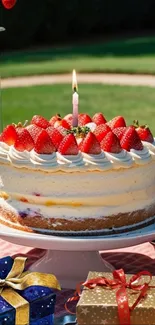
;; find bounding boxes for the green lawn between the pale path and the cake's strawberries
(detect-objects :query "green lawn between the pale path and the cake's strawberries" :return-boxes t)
[2,84,155,134]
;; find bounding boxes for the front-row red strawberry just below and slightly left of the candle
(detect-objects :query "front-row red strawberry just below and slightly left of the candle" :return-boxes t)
[58,134,79,155]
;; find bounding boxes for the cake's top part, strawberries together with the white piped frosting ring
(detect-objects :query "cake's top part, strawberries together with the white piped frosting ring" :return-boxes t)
[0,113,155,171]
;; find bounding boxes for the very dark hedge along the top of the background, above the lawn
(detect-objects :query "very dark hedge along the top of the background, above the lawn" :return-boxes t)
[0,0,155,48]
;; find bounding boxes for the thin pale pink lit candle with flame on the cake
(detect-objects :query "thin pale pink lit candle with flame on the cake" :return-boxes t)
[72,70,79,127]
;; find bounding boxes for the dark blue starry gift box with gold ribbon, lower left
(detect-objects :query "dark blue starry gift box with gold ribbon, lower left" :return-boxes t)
[0,257,60,325]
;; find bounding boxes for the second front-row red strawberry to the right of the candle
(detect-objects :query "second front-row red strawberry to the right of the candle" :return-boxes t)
[100,131,122,153]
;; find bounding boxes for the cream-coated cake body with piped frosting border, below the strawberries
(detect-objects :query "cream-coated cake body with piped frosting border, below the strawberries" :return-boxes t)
[0,137,155,231]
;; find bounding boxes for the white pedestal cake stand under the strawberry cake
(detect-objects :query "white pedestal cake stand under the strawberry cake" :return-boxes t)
[0,225,155,289]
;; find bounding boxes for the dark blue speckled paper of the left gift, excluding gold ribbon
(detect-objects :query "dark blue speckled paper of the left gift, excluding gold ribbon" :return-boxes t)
[0,256,56,325]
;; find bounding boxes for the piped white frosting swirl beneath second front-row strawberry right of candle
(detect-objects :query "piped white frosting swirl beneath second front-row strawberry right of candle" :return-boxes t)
[105,150,133,168]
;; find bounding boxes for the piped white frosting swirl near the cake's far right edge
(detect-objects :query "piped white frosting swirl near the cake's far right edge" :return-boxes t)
[130,147,152,165]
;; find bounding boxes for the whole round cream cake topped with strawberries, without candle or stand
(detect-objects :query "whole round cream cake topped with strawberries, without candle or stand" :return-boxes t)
[0,113,155,235]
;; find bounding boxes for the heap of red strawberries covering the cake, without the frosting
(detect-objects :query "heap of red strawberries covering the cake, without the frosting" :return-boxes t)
[0,113,154,155]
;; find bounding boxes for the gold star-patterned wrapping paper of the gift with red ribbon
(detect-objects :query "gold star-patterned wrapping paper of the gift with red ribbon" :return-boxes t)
[76,272,155,325]
